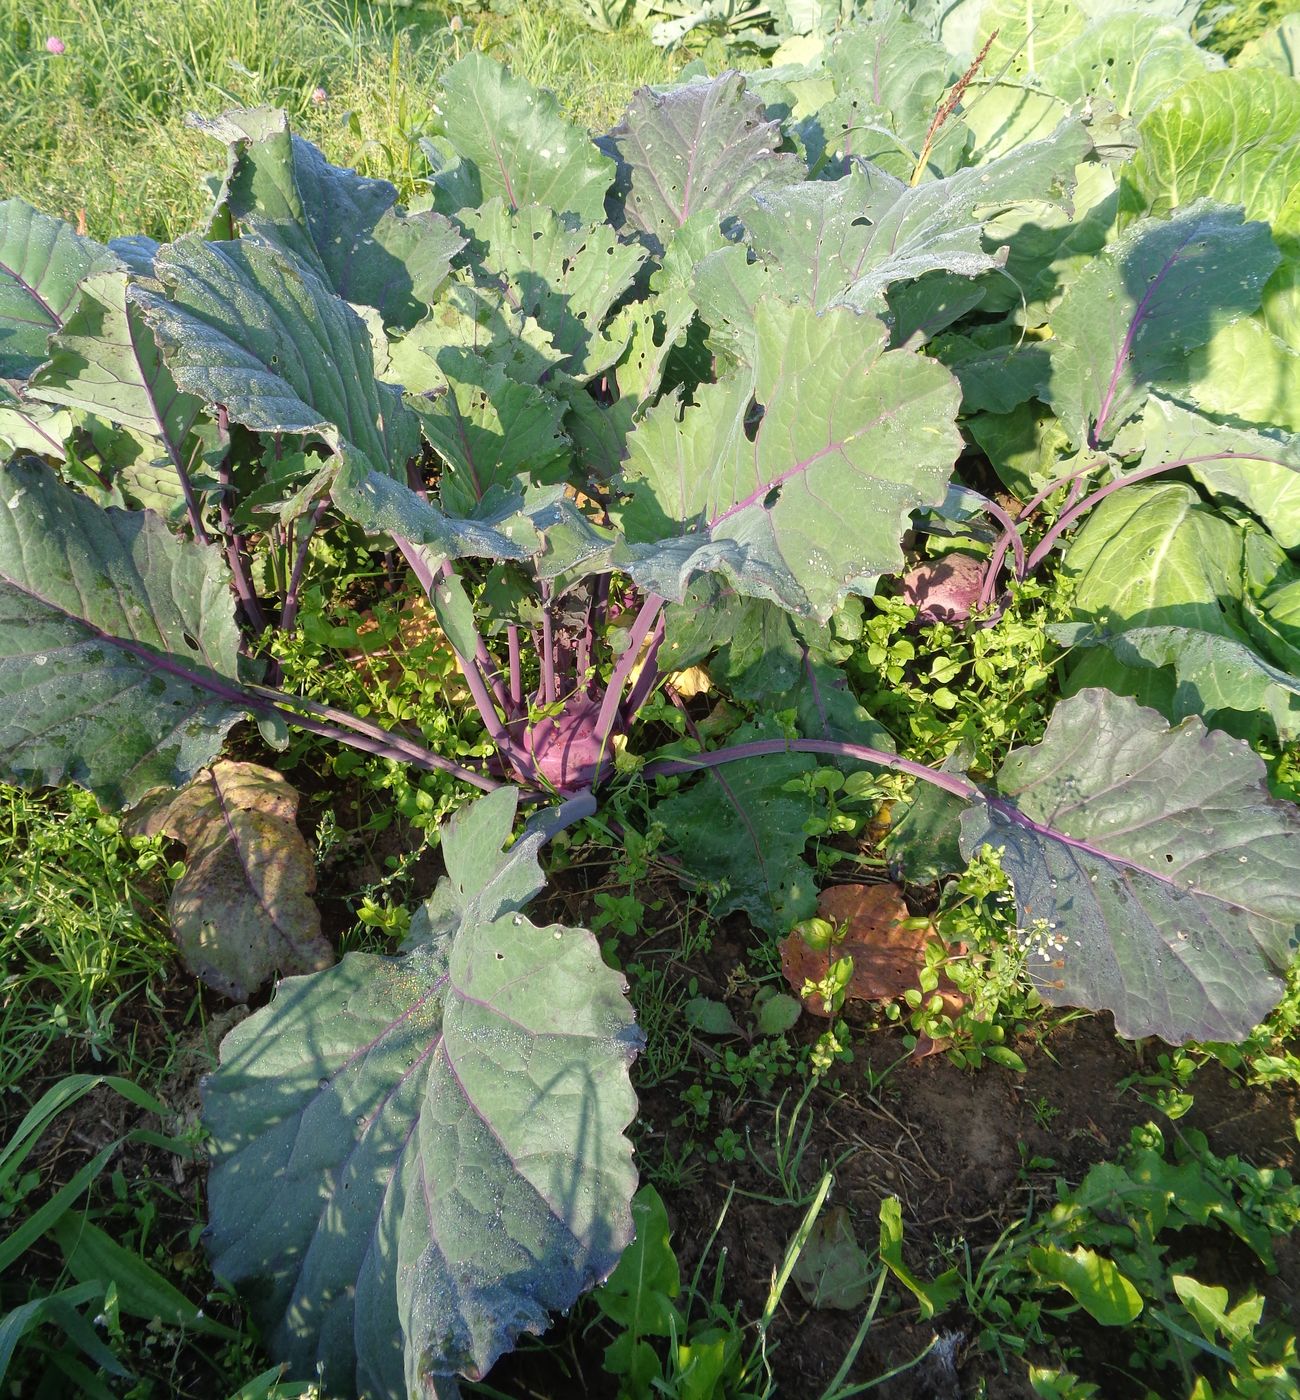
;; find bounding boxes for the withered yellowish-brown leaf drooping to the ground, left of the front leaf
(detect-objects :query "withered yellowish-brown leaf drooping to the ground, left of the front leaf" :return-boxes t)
[132,760,334,1001]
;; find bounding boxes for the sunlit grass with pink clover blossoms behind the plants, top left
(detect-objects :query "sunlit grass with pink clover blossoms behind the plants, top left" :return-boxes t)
[0,0,677,239]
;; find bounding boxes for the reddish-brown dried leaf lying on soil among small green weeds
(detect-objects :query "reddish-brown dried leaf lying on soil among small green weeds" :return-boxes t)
[781,885,964,1016]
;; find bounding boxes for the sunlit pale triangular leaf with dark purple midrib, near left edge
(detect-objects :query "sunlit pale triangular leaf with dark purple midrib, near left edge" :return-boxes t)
[28,272,204,468]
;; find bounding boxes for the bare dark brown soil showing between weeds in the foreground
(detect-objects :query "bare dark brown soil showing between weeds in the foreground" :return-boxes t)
[10,833,1300,1400]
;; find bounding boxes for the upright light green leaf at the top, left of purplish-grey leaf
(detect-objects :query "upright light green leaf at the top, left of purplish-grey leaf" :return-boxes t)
[439,53,614,223]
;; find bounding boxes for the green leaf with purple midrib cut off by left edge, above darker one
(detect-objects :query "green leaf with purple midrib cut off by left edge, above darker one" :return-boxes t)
[0,199,118,382]
